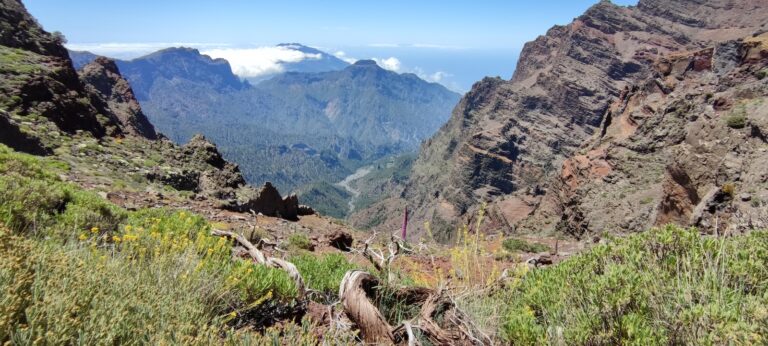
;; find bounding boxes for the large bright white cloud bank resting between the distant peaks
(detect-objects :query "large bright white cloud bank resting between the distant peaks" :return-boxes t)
[202,47,322,77]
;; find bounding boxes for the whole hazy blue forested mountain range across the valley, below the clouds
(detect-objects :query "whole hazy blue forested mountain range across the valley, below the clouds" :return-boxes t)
[70,44,460,216]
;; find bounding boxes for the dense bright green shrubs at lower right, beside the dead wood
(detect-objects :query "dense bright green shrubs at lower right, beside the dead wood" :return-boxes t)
[497,226,768,345]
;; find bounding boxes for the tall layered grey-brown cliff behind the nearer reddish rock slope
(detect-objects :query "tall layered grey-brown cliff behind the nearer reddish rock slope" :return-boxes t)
[354,1,766,238]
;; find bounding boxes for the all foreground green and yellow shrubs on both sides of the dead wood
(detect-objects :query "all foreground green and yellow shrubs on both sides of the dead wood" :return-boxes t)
[0,143,768,345]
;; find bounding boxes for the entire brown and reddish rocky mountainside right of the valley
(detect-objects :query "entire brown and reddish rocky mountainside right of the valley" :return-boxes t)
[354,0,768,241]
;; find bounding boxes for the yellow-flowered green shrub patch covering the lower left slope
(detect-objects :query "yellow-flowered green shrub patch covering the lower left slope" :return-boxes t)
[0,147,308,344]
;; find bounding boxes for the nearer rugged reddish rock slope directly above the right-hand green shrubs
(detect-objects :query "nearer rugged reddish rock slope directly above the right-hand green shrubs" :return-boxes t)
[519,34,768,237]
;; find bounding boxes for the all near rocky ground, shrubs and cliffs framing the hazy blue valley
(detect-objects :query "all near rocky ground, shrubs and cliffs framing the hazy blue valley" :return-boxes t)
[0,0,768,345]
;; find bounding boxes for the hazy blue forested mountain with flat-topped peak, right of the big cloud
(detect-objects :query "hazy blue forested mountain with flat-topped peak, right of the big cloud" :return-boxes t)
[255,60,458,152]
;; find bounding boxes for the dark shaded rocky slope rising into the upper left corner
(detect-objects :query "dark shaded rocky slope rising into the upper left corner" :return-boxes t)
[0,1,120,149]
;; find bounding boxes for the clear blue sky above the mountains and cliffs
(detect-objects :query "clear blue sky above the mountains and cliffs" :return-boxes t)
[24,0,637,92]
